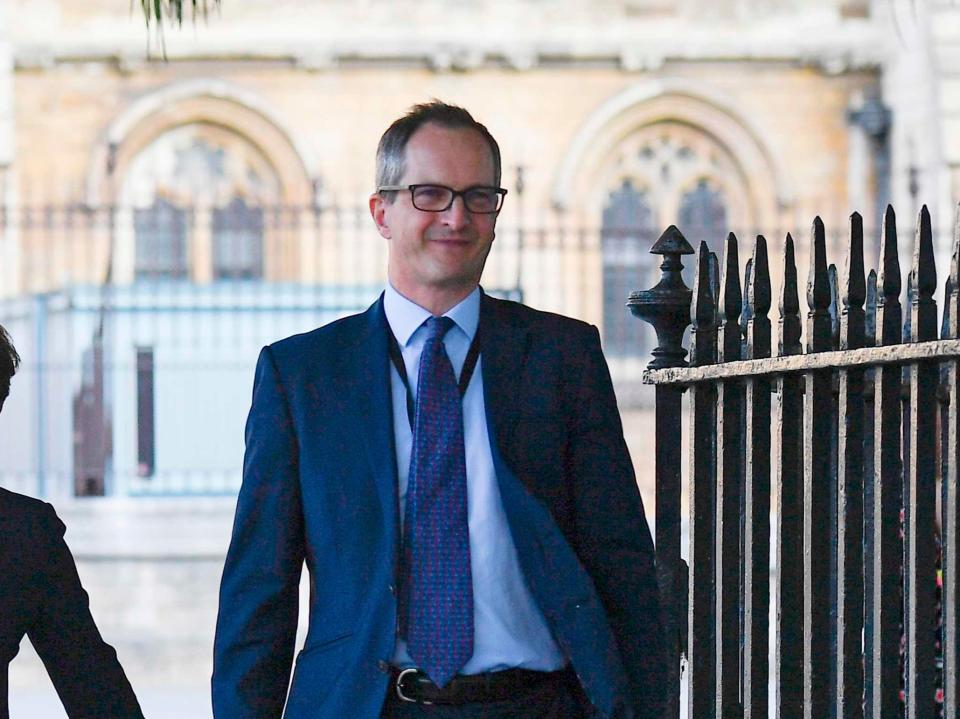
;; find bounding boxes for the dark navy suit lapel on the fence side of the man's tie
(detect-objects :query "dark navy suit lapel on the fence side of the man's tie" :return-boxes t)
[479,295,529,449]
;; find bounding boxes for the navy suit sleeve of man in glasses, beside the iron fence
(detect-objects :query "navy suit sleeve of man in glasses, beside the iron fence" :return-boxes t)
[565,327,666,719]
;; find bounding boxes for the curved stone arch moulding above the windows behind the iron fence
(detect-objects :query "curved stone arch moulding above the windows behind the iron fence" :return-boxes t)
[552,80,793,229]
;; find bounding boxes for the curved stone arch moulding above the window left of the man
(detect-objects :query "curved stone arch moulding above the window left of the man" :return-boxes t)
[87,79,319,207]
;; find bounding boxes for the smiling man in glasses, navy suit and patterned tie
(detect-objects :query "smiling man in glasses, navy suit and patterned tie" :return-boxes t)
[212,101,665,719]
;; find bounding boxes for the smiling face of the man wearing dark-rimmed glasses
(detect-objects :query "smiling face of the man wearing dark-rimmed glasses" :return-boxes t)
[370,123,497,304]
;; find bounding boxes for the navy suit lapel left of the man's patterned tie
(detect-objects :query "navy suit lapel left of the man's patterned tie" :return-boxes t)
[345,295,399,537]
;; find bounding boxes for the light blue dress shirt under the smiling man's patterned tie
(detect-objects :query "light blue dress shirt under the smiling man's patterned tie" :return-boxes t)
[383,284,566,674]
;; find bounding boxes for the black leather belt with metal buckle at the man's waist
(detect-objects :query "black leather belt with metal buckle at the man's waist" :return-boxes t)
[390,667,572,704]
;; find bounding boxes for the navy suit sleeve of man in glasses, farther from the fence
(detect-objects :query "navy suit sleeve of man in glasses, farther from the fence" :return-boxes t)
[212,347,304,719]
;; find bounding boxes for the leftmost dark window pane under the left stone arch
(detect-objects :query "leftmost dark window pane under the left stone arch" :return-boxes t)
[133,198,187,279]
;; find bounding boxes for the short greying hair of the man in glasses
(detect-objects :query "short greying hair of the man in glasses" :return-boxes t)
[377,100,500,197]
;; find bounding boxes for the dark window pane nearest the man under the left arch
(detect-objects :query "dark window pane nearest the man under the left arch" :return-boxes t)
[213,197,263,279]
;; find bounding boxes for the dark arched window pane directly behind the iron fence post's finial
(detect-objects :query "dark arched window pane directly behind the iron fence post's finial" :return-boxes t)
[601,180,656,357]
